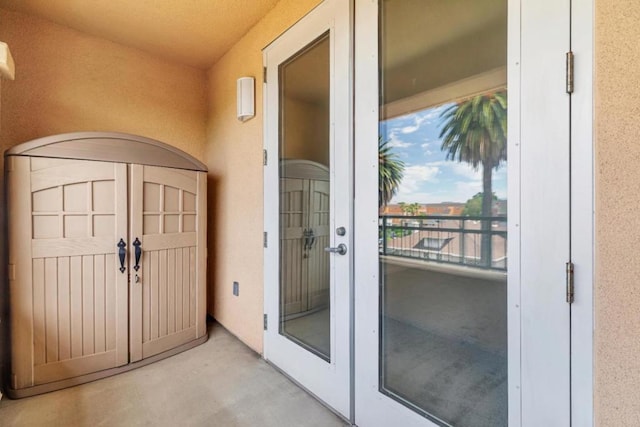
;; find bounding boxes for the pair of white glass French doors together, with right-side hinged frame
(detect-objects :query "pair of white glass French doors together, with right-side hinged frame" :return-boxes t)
[264,0,593,427]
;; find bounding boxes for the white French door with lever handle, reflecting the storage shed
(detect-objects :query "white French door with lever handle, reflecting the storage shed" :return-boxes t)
[264,0,353,418]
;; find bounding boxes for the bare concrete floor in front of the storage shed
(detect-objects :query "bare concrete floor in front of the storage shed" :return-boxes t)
[0,323,348,427]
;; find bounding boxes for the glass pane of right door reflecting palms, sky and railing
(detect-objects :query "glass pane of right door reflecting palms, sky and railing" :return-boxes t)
[378,0,507,427]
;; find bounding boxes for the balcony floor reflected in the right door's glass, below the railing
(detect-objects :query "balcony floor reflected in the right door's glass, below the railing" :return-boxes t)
[381,257,507,427]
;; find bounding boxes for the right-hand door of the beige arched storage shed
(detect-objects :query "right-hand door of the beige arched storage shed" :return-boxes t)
[129,165,207,361]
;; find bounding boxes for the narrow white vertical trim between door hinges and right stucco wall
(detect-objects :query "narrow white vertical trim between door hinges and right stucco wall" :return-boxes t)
[571,0,595,427]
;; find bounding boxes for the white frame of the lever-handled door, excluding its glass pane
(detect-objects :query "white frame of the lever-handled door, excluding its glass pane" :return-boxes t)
[263,0,354,419]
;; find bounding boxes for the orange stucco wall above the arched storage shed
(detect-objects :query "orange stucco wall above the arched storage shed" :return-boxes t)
[0,9,207,159]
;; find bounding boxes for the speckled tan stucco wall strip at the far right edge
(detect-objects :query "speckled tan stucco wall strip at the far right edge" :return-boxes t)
[594,0,640,426]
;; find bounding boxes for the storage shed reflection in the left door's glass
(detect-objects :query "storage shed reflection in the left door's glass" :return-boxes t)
[280,160,330,315]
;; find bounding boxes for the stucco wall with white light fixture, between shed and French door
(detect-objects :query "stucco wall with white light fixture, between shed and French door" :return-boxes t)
[206,0,319,352]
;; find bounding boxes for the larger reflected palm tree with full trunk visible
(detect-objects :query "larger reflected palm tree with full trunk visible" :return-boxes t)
[440,91,507,266]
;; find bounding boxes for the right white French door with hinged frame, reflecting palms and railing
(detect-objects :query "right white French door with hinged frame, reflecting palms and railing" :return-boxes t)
[354,0,593,426]
